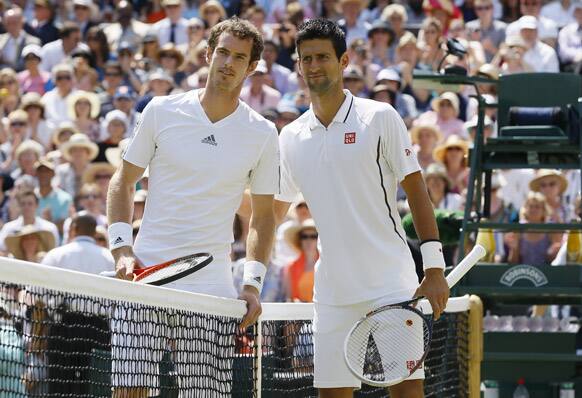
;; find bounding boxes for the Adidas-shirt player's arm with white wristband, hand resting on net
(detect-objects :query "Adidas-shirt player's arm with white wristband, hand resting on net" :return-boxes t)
[240,195,275,330]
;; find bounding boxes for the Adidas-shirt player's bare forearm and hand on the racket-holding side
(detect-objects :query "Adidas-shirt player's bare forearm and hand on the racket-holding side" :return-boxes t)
[107,160,145,280]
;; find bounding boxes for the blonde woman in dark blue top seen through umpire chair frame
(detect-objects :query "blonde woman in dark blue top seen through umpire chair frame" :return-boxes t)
[504,192,562,265]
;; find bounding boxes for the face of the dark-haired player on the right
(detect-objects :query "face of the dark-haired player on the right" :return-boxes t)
[298,39,349,94]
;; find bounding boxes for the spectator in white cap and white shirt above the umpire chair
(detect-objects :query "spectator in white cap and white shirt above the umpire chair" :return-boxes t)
[518,15,560,73]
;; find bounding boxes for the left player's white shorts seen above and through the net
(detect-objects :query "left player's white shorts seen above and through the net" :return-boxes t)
[111,282,236,397]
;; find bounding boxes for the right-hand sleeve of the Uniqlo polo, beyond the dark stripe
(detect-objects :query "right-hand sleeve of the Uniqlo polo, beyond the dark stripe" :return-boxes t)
[380,107,420,182]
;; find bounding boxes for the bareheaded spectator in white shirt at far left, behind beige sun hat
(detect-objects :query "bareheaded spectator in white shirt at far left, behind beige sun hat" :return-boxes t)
[0,190,60,251]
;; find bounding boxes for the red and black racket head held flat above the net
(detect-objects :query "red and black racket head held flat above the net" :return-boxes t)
[133,253,213,286]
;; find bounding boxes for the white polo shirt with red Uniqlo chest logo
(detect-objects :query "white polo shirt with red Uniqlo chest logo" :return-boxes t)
[277,90,420,305]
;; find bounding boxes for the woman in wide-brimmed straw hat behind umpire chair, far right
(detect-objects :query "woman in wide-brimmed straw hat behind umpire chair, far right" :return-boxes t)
[529,169,570,223]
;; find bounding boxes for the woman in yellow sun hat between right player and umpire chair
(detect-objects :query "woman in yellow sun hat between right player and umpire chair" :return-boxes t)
[434,135,470,194]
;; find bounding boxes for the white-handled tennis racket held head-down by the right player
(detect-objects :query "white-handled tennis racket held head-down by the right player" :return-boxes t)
[344,245,486,387]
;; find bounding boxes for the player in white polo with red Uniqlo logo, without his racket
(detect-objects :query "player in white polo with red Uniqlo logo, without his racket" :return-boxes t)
[275,19,449,398]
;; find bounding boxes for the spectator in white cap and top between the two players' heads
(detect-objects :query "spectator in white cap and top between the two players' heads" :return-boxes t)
[240,60,281,113]
